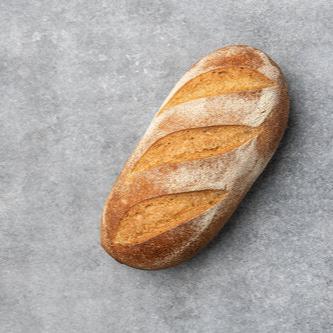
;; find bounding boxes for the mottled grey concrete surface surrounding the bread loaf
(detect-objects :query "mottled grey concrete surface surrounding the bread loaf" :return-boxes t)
[0,0,333,333]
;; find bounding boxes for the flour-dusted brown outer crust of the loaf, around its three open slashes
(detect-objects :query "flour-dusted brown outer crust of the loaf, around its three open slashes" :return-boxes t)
[101,45,288,269]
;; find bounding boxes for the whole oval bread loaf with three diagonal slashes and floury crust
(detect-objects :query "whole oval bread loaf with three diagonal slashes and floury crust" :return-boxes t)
[101,45,288,269]
